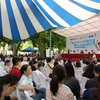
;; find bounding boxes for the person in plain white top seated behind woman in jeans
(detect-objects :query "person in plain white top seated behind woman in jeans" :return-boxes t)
[32,62,48,89]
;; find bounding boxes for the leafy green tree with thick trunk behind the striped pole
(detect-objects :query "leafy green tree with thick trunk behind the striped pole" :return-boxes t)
[30,29,66,56]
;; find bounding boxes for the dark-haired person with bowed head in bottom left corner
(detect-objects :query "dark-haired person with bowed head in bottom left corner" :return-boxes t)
[0,74,18,100]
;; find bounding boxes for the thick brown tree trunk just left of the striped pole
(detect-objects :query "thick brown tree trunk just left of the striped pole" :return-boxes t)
[38,33,45,57]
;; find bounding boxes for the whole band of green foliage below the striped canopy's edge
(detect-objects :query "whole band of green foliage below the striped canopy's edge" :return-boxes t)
[0,29,66,53]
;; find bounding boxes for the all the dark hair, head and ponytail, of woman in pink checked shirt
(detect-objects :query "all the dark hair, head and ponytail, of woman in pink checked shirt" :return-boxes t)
[50,65,66,96]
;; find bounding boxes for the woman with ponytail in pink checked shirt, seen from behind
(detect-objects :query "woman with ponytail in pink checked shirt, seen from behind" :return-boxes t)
[46,65,74,100]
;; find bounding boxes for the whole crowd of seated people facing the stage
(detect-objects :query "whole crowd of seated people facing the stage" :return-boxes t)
[0,56,100,100]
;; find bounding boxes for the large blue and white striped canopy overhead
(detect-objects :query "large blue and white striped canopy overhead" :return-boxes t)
[0,0,100,40]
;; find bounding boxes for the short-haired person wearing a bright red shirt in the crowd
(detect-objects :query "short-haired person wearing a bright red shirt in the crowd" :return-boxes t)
[11,57,21,77]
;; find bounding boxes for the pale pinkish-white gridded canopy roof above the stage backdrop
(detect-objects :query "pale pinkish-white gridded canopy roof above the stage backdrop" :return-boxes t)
[53,14,100,37]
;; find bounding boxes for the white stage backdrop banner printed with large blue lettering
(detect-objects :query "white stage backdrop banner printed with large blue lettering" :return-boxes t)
[66,32,100,53]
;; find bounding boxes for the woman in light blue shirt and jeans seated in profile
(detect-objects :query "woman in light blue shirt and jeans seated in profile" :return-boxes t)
[19,65,46,100]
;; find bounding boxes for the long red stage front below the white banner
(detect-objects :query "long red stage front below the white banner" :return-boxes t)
[60,54,100,61]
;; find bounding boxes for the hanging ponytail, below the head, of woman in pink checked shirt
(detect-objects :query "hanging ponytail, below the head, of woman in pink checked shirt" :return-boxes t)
[50,76,58,96]
